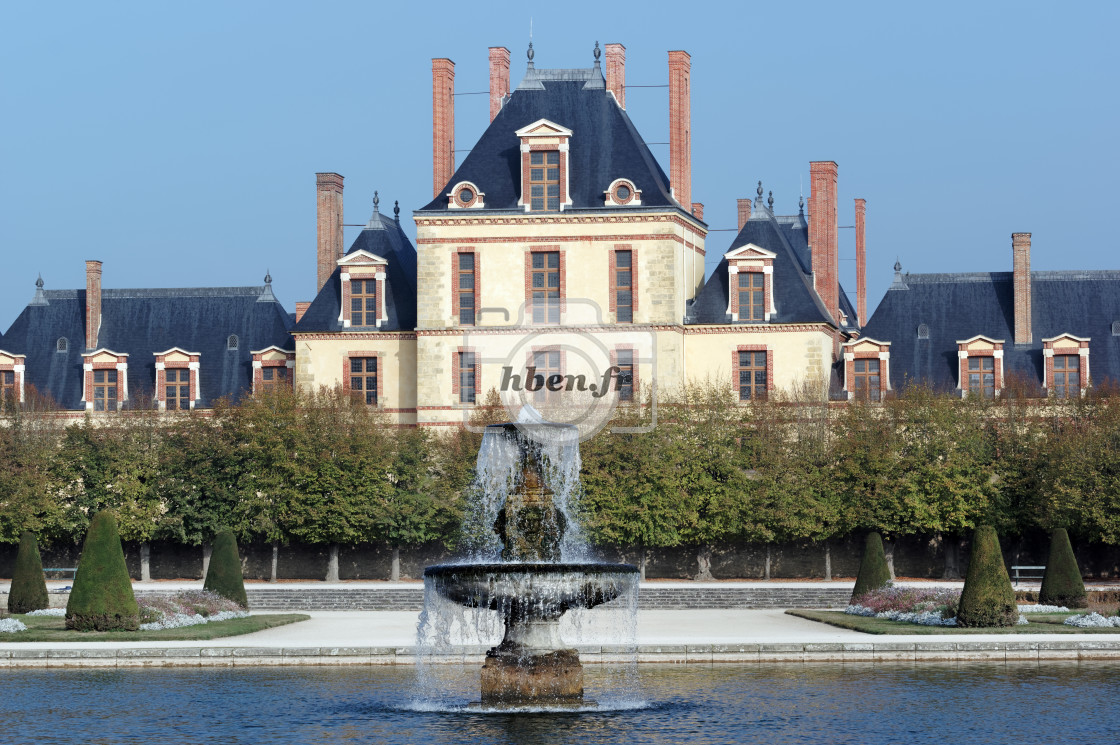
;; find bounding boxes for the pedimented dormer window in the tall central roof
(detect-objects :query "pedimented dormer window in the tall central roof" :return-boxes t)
[515,119,571,212]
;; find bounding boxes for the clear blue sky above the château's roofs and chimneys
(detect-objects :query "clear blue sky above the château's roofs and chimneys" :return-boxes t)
[0,1,1120,329]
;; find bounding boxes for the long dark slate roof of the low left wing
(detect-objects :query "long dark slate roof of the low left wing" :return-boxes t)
[3,285,295,409]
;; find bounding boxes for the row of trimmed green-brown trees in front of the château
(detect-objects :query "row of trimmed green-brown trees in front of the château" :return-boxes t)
[0,385,1120,571]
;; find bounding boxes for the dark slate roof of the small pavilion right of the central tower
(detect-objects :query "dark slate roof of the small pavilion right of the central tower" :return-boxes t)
[685,203,856,330]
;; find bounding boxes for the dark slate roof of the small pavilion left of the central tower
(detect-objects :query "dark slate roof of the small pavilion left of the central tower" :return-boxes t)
[292,203,417,334]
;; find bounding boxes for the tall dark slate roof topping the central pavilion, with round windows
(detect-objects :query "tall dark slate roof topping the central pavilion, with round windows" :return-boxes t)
[418,62,685,214]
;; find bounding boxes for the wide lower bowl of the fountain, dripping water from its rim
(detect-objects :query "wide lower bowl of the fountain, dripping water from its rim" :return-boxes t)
[423,562,638,618]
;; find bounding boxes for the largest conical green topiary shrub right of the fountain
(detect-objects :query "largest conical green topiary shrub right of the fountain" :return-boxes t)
[956,525,1019,627]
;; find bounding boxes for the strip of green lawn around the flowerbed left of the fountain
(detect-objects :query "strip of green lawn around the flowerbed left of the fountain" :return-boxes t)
[0,613,311,642]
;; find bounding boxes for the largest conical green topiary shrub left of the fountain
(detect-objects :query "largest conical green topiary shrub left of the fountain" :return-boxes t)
[66,510,140,631]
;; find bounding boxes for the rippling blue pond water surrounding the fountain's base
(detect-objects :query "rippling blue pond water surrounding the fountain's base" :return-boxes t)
[0,662,1120,745]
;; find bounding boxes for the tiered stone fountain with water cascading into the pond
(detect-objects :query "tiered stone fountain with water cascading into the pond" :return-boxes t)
[420,423,637,708]
